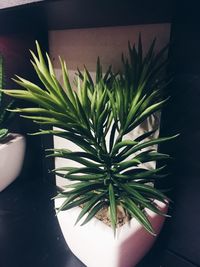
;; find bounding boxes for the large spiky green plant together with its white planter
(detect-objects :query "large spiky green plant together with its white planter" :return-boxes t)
[3,38,175,267]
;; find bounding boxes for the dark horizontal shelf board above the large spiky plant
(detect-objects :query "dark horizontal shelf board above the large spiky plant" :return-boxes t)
[0,0,174,33]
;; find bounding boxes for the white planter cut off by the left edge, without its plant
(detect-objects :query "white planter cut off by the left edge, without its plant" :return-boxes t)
[0,134,25,191]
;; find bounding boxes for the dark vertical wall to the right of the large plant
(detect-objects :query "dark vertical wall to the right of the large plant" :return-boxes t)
[160,1,200,267]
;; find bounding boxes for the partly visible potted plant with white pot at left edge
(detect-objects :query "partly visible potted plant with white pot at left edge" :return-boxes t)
[0,56,25,191]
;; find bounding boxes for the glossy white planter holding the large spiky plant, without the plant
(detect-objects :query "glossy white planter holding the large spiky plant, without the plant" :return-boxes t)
[55,199,167,267]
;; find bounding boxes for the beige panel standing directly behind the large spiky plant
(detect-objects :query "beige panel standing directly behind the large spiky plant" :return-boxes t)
[49,24,170,184]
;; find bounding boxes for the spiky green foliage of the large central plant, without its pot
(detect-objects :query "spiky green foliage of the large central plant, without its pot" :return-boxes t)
[3,40,177,237]
